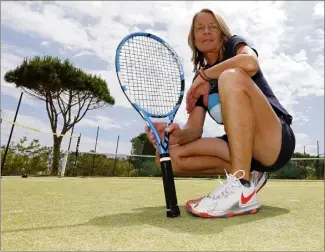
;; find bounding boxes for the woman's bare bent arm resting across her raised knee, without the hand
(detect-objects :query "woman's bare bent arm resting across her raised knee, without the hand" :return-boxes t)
[204,43,259,79]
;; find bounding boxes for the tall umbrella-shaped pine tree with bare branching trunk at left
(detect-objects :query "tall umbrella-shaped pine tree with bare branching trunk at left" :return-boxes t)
[4,56,115,175]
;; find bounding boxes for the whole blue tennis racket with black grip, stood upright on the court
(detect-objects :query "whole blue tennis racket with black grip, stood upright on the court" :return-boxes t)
[115,32,185,217]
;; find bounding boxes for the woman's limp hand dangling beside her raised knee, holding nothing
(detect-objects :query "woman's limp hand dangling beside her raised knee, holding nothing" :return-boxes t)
[186,75,210,114]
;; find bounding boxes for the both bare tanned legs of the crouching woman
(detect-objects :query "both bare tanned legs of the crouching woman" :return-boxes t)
[157,69,282,180]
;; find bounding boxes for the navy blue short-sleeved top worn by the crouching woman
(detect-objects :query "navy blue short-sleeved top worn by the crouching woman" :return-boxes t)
[193,35,292,124]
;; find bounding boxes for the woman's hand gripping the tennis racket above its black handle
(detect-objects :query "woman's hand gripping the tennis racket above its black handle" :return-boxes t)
[144,122,181,149]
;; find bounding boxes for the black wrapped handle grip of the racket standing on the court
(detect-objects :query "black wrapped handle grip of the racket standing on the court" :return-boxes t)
[160,154,180,218]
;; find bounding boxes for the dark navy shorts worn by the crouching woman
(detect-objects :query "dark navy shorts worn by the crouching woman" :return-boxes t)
[217,117,296,172]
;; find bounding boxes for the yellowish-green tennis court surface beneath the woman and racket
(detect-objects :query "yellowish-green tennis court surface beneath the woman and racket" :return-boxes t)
[1,177,324,251]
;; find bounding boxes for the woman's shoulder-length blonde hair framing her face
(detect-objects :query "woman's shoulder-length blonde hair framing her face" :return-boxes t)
[188,9,231,72]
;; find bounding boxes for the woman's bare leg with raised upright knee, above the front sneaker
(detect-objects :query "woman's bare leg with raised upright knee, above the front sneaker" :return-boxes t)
[219,68,282,180]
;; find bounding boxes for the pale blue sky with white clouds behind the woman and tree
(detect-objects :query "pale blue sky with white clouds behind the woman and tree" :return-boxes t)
[1,1,324,157]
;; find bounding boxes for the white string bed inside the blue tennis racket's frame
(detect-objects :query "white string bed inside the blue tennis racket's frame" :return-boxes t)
[119,37,181,115]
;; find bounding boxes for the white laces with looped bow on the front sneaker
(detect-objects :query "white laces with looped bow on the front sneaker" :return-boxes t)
[208,170,245,199]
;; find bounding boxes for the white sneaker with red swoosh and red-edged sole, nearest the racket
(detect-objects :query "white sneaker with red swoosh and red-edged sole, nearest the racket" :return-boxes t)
[192,170,261,218]
